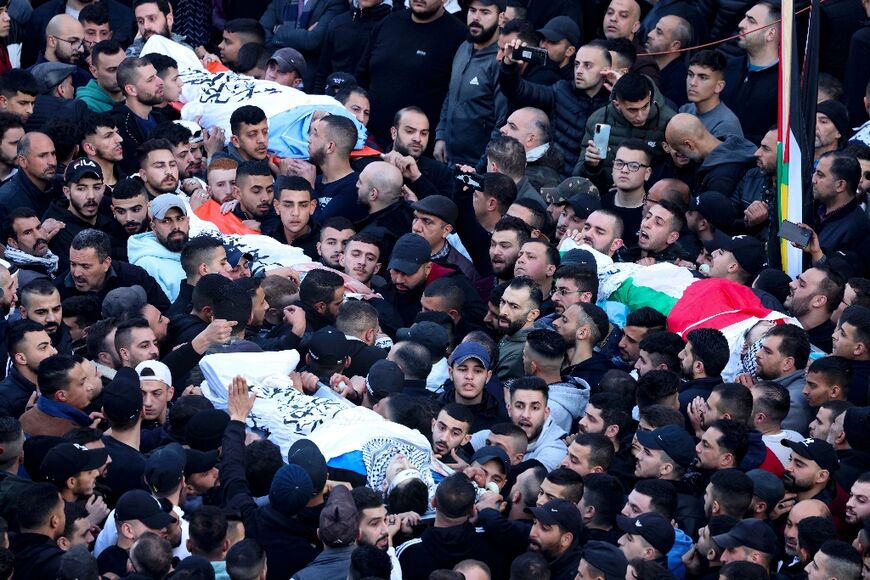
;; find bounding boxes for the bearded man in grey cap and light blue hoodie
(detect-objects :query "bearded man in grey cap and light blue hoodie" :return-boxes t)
[127,193,190,302]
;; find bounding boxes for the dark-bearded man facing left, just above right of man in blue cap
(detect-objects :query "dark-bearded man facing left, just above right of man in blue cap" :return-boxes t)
[496,276,543,381]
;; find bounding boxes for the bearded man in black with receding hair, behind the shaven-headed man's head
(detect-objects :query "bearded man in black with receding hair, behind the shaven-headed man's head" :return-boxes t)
[384,106,453,199]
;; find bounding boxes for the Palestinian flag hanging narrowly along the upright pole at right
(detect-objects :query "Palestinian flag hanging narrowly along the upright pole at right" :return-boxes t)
[769,0,820,277]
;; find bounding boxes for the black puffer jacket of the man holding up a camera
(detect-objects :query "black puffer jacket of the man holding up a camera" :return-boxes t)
[499,64,610,175]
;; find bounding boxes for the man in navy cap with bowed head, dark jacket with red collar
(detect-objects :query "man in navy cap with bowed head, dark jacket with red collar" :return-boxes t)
[384,234,486,326]
